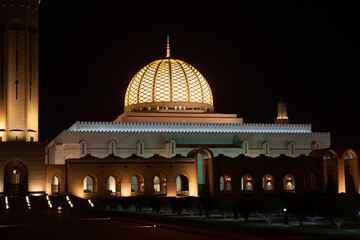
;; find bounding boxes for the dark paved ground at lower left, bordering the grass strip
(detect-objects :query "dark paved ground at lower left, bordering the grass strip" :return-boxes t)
[0,209,250,240]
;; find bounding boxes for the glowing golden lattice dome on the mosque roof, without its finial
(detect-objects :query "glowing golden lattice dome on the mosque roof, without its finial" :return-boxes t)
[125,58,214,111]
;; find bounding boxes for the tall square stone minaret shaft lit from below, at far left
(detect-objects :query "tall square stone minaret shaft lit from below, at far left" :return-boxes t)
[0,0,40,142]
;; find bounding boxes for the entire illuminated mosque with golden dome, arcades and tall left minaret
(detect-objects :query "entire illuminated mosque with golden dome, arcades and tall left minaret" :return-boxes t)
[0,0,360,198]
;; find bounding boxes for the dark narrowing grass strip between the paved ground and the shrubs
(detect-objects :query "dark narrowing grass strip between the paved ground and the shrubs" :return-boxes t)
[86,210,360,239]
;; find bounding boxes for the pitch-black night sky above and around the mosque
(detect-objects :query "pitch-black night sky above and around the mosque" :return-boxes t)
[39,0,360,148]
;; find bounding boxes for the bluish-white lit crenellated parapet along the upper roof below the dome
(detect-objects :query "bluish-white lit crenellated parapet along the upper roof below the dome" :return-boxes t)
[67,122,318,133]
